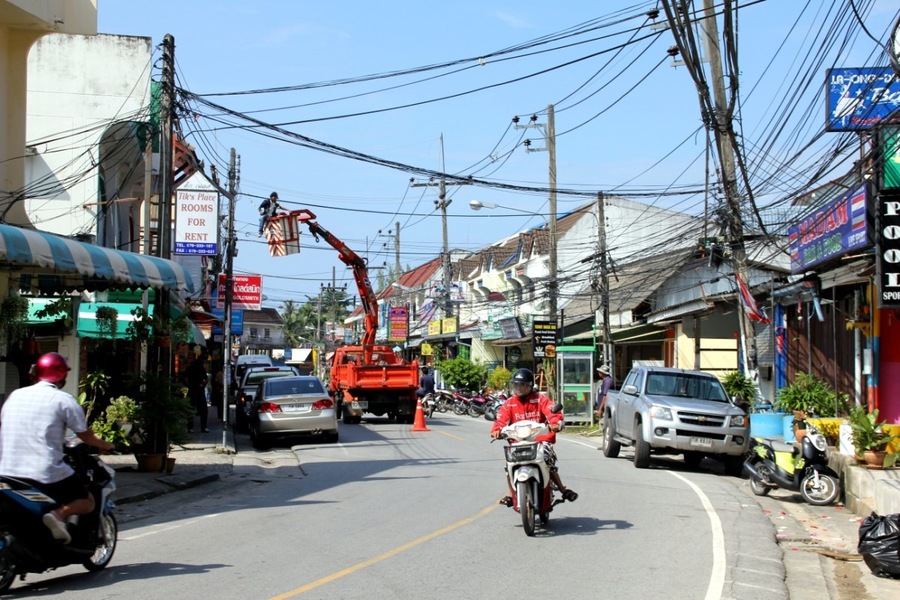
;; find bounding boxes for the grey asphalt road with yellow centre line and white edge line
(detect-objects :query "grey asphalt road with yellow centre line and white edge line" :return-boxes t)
[13,415,864,600]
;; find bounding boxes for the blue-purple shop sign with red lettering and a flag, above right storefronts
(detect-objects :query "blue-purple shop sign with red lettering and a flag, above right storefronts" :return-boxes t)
[788,185,871,274]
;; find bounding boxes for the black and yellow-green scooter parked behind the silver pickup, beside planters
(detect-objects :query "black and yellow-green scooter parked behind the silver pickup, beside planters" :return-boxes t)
[744,412,841,506]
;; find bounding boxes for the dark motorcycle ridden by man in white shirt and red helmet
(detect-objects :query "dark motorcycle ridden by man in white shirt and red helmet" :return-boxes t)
[0,442,118,593]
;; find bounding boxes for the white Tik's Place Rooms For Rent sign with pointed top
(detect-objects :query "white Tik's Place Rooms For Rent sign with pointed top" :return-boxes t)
[175,173,219,256]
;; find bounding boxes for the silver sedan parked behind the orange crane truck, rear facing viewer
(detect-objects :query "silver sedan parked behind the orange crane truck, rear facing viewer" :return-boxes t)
[250,375,338,449]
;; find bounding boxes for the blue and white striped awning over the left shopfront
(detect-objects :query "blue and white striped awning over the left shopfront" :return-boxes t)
[0,225,194,294]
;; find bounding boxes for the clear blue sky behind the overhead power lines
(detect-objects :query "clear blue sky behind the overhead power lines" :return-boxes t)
[98,0,897,307]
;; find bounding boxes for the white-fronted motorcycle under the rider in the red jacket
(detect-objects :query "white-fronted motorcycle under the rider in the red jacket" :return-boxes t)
[491,421,565,537]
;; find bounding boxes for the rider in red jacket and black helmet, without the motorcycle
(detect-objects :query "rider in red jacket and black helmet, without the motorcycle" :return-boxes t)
[491,369,578,506]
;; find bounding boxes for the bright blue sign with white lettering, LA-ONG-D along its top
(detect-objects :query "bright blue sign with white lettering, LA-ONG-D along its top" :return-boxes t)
[825,67,900,131]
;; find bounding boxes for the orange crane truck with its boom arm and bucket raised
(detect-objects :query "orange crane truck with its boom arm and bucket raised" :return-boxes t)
[266,209,419,425]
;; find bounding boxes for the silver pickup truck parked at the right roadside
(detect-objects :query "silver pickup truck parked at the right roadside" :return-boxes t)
[603,367,750,476]
